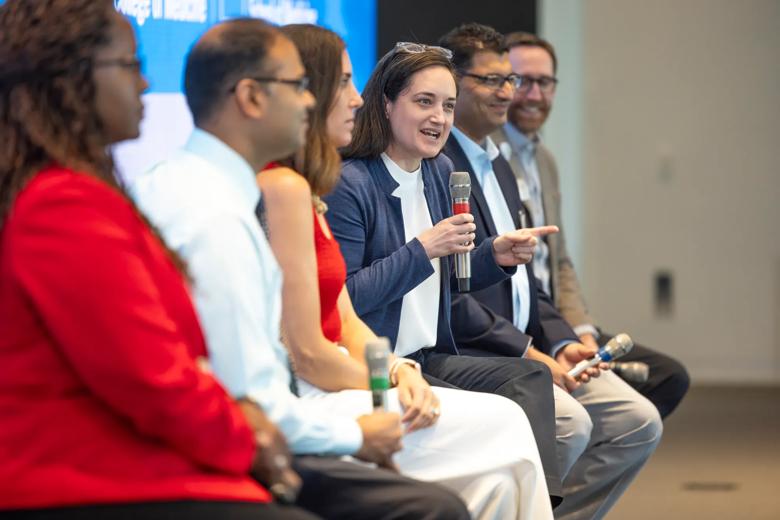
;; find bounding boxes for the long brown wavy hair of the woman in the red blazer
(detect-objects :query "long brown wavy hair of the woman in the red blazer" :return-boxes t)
[0,0,186,276]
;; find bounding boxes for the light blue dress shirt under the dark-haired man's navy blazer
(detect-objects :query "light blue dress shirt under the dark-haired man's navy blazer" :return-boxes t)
[452,126,531,331]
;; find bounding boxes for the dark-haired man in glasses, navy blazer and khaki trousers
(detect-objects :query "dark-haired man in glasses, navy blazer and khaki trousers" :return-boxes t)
[439,24,662,520]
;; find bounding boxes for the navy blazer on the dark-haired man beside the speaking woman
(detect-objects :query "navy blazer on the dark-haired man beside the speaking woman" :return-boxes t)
[444,134,579,354]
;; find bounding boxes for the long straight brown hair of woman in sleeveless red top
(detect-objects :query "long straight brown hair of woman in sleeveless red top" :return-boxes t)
[281,24,345,196]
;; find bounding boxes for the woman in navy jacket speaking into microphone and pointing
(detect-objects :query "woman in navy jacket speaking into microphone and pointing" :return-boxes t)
[325,39,560,504]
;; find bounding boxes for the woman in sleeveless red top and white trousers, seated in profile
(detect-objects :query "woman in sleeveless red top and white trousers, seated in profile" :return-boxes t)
[257,25,552,520]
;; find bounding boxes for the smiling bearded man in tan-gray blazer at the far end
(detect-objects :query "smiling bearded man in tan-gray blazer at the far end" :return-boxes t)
[491,32,689,417]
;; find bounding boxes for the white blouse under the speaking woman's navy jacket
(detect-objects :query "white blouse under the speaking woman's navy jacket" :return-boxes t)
[382,153,441,356]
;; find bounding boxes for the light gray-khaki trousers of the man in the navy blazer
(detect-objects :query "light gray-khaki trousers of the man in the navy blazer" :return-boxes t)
[554,371,663,520]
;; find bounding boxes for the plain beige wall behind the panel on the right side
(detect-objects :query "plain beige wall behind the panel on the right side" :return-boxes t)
[540,0,780,383]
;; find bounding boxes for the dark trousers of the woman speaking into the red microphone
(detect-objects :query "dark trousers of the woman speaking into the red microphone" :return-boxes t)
[410,348,563,506]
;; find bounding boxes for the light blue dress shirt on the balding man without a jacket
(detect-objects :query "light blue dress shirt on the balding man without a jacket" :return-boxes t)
[131,129,363,455]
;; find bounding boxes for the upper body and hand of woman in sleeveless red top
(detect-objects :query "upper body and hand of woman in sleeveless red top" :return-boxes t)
[258,25,439,431]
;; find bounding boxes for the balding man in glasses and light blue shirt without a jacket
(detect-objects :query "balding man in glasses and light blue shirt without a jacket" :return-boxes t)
[131,19,468,518]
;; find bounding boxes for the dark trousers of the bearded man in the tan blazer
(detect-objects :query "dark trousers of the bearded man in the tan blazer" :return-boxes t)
[599,338,691,419]
